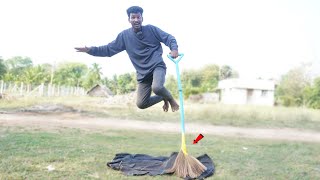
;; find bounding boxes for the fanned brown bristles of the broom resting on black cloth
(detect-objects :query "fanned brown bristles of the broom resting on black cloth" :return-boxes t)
[166,150,207,178]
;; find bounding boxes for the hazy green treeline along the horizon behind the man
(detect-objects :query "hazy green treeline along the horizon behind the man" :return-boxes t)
[0,56,320,109]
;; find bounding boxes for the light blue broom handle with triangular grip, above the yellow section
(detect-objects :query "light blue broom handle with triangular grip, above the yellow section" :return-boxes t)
[167,54,185,134]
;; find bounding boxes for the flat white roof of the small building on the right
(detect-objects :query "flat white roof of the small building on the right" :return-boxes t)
[217,78,275,90]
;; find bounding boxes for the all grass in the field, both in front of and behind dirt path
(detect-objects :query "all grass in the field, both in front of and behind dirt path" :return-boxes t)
[0,97,320,180]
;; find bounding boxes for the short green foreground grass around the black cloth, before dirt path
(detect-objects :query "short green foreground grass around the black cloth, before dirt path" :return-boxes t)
[0,127,320,180]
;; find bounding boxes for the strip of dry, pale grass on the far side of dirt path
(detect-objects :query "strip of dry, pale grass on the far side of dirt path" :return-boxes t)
[0,97,320,131]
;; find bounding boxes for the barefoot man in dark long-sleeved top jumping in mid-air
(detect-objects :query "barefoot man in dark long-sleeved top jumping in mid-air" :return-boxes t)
[75,6,179,112]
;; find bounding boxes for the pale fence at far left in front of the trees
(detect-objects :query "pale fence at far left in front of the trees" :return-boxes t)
[0,80,86,97]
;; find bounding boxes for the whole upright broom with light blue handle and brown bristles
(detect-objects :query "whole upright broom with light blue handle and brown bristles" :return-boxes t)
[166,54,207,178]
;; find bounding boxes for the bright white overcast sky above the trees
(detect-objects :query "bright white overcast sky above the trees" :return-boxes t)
[0,0,320,79]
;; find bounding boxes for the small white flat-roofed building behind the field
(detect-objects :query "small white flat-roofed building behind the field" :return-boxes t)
[217,79,275,106]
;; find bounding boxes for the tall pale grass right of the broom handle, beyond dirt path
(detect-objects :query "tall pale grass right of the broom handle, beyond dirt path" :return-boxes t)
[186,104,320,130]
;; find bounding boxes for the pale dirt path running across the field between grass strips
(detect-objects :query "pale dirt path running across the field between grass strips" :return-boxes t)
[0,111,320,143]
